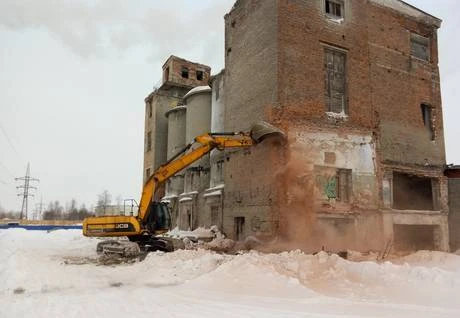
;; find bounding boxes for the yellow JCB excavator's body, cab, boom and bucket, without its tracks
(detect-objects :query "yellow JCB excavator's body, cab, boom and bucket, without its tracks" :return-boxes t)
[83,123,284,253]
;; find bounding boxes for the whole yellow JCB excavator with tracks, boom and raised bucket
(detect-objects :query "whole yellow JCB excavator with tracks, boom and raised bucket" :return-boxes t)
[83,122,284,257]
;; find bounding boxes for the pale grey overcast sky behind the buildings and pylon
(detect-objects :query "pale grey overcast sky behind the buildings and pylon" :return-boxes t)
[0,0,460,214]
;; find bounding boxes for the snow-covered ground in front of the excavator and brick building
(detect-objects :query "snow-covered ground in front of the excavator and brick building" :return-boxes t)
[0,229,460,318]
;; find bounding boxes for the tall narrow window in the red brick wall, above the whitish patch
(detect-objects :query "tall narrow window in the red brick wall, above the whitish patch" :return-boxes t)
[324,48,348,114]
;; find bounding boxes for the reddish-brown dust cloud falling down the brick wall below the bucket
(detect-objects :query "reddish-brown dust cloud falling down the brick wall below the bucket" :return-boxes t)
[257,140,366,253]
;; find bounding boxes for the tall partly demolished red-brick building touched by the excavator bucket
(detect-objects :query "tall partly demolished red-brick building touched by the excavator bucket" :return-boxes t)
[145,0,449,250]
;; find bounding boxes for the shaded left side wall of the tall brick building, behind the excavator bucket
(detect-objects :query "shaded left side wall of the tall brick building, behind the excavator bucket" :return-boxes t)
[223,0,277,238]
